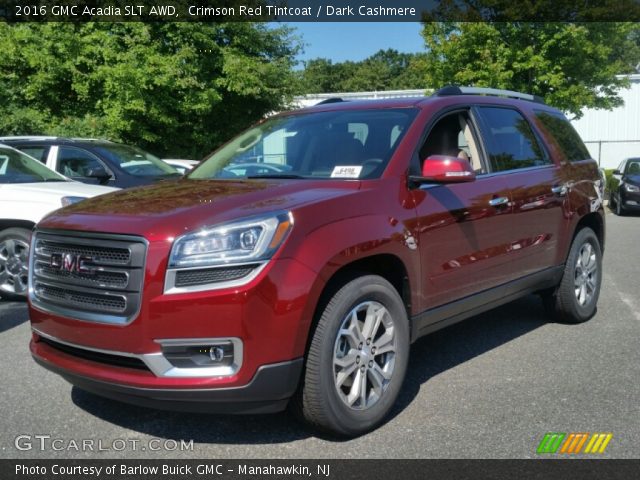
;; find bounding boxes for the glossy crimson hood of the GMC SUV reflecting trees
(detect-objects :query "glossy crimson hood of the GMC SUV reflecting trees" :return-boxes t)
[39,178,360,240]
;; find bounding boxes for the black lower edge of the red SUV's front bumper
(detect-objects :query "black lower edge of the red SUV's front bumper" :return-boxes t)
[30,340,303,413]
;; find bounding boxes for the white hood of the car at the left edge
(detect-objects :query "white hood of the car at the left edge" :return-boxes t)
[0,181,118,202]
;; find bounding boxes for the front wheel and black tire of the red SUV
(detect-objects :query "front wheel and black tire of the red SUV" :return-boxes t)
[296,275,409,437]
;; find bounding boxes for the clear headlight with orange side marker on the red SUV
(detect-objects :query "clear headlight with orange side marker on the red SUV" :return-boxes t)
[169,212,293,268]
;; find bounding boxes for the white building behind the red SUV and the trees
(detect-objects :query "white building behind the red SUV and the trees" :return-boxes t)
[294,73,640,168]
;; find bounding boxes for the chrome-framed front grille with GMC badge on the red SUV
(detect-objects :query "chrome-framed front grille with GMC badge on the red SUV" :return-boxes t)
[29,230,147,324]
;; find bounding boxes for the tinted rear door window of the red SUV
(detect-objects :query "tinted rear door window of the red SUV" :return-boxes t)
[477,107,551,172]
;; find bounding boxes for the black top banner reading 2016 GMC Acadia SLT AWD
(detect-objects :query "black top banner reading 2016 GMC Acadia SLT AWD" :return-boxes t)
[0,0,640,22]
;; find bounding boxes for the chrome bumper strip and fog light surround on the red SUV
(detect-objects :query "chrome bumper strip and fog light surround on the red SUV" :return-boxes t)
[31,327,244,378]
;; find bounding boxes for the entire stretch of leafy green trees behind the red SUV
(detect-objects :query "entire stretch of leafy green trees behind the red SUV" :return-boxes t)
[0,20,640,158]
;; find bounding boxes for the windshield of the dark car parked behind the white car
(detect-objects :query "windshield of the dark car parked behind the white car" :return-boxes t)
[95,144,180,177]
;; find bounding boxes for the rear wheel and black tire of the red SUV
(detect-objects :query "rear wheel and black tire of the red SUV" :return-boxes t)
[542,227,602,323]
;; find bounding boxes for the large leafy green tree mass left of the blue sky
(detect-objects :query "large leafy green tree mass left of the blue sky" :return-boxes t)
[0,22,299,158]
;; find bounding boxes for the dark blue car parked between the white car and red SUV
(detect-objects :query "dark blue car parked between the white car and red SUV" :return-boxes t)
[0,137,181,188]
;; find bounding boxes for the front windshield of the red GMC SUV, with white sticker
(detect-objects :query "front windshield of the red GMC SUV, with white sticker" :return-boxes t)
[188,108,417,179]
